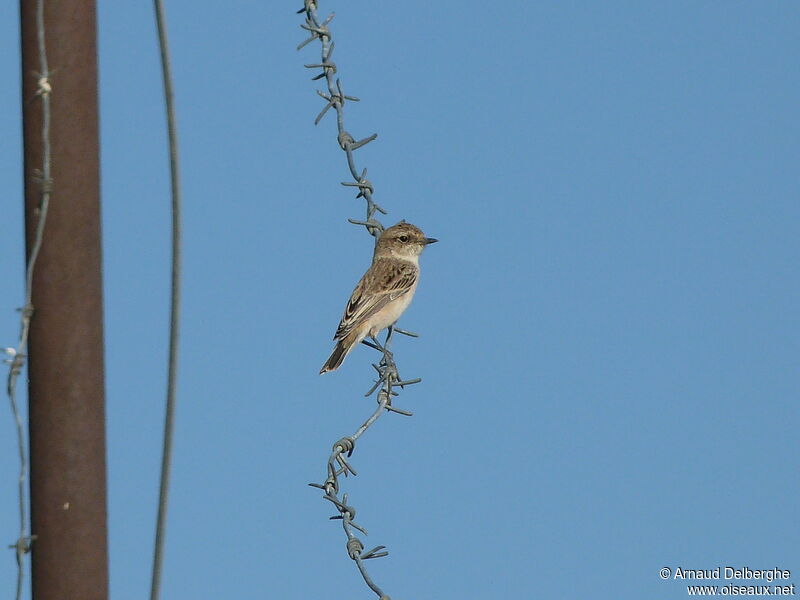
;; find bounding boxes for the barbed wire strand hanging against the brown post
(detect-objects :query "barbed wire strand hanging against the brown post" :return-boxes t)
[3,0,53,600]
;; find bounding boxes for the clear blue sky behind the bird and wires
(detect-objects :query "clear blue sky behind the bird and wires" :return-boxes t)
[0,0,800,600]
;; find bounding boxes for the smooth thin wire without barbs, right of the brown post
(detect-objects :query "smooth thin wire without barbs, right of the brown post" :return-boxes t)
[150,0,181,600]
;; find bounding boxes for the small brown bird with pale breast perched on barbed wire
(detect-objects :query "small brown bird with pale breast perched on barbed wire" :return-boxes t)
[319,221,438,375]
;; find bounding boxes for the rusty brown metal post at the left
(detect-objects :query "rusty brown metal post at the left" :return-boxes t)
[20,0,108,600]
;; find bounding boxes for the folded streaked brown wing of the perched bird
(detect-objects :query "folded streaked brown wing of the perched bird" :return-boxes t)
[333,259,419,340]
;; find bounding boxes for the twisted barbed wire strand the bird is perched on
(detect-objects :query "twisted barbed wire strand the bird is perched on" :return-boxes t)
[297,0,422,600]
